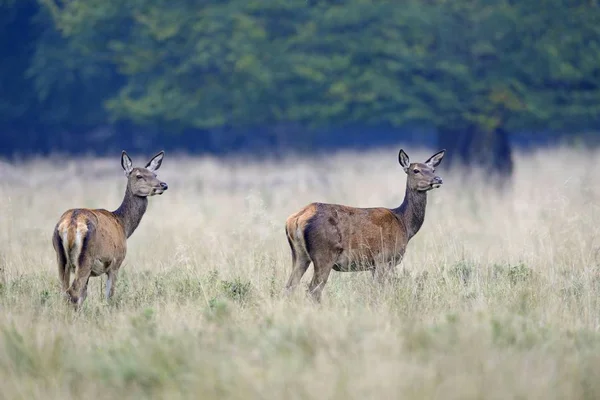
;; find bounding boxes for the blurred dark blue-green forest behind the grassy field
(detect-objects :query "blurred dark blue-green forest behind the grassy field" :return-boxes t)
[0,0,600,174]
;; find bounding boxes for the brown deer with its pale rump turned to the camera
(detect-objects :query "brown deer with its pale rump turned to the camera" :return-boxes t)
[52,151,168,308]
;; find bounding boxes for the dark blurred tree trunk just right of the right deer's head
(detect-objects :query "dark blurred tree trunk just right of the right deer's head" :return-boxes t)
[438,127,513,179]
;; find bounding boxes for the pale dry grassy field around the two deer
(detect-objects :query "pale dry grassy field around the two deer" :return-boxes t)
[0,148,600,399]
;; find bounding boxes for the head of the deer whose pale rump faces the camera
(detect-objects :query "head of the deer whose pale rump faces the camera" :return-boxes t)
[121,150,169,197]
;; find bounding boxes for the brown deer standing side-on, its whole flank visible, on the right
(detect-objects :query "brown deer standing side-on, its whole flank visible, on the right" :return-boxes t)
[285,149,445,302]
